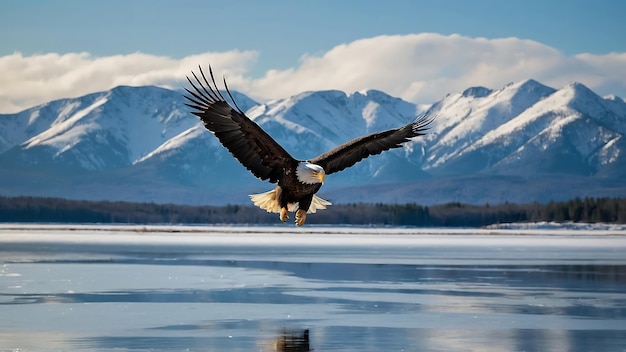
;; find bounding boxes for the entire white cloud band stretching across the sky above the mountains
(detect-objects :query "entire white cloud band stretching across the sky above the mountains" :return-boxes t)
[0,33,626,112]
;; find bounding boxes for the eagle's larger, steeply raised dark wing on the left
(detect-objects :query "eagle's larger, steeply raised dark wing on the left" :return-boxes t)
[185,66,296,182]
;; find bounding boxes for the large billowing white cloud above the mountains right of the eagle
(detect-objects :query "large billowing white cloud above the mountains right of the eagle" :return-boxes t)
[247,33,626,103]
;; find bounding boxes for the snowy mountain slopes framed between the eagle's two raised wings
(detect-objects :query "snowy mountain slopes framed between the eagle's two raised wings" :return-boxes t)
[249,90,417,159]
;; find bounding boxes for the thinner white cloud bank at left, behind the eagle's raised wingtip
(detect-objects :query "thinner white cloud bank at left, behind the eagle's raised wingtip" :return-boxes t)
[0,51,257,113]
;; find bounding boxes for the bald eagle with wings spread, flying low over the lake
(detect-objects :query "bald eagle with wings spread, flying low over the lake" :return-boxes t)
[185,66,433,226]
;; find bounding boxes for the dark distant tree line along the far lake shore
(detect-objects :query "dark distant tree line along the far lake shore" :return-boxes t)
[0,196,626,227]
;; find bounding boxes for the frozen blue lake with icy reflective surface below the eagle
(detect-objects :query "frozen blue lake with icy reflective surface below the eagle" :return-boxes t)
[0,224,626,352]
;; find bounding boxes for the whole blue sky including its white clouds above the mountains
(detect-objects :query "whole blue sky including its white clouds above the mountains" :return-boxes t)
[0,0,626,113]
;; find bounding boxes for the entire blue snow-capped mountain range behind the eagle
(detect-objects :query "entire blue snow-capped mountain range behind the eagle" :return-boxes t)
[0,80,626,205]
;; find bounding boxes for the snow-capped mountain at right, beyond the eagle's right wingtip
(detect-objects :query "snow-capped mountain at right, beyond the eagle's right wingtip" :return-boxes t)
[426,80,626,176]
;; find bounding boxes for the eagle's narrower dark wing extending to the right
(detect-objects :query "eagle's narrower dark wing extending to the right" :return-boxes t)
[309,114,434,174]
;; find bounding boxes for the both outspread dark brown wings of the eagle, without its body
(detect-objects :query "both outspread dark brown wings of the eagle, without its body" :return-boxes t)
[185,66,434,182]
